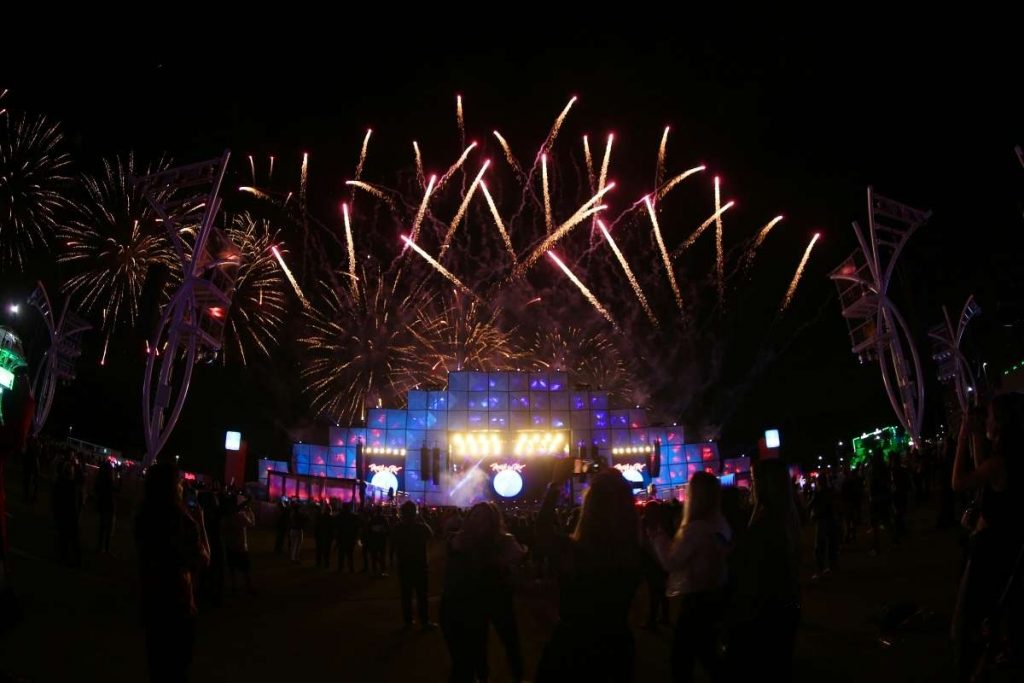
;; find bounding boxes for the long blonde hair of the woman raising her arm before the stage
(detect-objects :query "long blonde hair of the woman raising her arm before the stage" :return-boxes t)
[572,470,640,565]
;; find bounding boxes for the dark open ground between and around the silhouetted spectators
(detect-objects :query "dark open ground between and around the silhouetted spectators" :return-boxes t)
[0,463,959,682]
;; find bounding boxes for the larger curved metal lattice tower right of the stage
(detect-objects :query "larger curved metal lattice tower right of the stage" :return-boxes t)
[829,187,931,439]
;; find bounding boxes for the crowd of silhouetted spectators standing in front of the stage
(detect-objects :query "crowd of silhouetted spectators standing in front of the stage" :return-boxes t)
[4,395,1024,682]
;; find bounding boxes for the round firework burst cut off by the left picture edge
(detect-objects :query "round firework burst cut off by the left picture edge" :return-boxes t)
[0,114,72,270]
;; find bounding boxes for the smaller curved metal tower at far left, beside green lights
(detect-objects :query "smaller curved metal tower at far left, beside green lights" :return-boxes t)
[29,282,92,435]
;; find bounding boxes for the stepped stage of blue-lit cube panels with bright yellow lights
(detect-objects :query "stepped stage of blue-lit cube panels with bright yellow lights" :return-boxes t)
[284,371,721,506]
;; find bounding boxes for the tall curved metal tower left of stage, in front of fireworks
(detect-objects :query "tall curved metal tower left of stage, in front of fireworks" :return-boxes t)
[136,151,241,465]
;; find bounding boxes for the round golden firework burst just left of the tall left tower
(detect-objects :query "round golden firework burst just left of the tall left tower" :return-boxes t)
[58,155,179,339]
